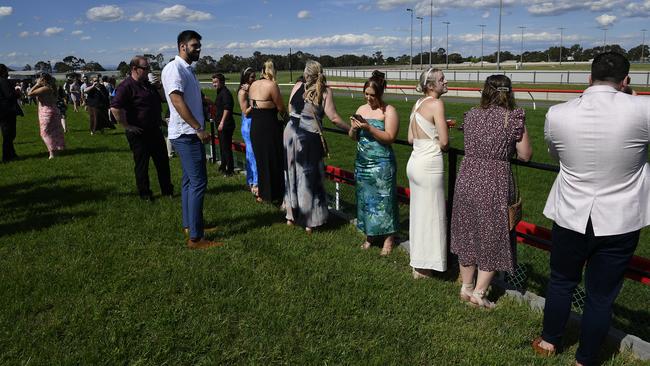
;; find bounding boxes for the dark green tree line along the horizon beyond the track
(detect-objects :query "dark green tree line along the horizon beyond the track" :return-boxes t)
[15,44,650,76]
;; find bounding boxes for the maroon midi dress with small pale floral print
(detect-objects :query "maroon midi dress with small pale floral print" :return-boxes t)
[451,107,526,272]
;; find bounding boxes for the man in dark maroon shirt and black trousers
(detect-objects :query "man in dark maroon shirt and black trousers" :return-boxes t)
[111,56,174,201]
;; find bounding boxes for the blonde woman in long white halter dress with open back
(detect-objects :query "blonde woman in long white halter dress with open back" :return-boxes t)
[406,68,449,279]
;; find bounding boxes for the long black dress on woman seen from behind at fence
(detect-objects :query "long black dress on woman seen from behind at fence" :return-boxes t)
[251,100,285,202]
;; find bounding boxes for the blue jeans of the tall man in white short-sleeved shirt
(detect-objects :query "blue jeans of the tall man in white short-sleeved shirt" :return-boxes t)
[170,135,208,239]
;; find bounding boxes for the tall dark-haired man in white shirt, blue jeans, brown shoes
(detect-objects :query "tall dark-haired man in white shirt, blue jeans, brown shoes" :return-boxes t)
[162,30,223,249]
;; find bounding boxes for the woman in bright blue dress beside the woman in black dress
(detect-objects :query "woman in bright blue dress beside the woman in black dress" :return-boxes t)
[237,67,257,197]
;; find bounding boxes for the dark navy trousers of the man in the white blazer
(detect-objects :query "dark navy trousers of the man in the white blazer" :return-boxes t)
[542,220,640,365]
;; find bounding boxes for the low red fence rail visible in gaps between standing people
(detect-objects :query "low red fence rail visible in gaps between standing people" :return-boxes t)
[214,137,650,286]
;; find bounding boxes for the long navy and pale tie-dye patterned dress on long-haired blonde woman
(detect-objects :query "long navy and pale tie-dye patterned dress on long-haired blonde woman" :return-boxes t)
[284,84,329,227]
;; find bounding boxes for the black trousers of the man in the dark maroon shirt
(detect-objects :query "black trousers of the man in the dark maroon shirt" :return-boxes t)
[126,128,174,197]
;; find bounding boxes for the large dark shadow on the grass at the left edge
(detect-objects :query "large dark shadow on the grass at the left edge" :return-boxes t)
[0,175,108,237]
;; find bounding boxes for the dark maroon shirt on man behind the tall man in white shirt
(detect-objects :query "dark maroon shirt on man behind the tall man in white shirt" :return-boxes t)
[111,76,162,129]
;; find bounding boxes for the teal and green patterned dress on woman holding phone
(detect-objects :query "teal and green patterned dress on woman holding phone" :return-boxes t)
[354,119,399,236]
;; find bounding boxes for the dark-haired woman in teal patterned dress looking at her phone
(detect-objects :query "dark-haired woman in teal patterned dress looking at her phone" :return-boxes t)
[350,70,399,255]
